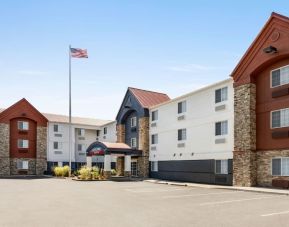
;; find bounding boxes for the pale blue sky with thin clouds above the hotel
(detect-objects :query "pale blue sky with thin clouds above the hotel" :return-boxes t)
[0,0,289,120]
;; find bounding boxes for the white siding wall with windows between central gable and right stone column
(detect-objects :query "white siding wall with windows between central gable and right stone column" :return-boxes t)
[150,80,234,161]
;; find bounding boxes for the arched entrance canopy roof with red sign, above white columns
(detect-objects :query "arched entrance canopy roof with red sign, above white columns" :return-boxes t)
[86,141,141,156]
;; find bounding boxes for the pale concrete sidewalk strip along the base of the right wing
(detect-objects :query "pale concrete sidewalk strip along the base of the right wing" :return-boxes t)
[144,179,289,195]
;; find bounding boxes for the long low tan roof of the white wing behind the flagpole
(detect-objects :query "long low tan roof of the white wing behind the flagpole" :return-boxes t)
[43,113,113,126]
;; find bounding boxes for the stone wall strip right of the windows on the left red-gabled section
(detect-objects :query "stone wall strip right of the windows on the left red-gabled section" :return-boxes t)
[36,126,47,175]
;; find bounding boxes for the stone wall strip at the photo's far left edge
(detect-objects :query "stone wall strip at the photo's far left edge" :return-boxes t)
[0,123,10,176]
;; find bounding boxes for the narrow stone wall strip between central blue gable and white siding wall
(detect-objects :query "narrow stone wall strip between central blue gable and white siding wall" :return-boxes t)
[138,117,149,177]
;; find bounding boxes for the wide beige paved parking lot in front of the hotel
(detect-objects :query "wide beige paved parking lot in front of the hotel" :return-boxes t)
[0,178,289,227]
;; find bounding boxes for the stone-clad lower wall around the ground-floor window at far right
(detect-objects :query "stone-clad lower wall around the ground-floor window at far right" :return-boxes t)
[257,150,289,187]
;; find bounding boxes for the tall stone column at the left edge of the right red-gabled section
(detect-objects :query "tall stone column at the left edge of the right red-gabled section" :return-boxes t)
[233,83,257,187]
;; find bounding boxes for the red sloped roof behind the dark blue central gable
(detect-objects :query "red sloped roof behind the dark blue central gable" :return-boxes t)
[128,87,170,108]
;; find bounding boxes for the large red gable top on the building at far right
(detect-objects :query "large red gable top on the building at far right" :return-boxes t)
[231,12,289,84]
